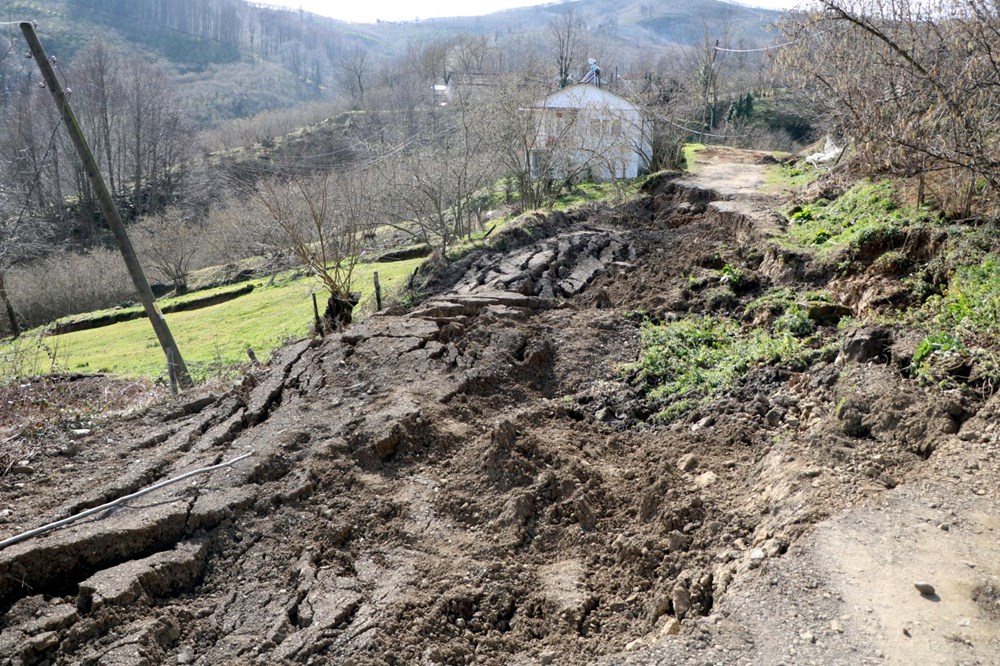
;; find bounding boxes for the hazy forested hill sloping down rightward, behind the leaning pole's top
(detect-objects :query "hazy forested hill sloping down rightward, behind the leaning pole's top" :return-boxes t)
[0,0,378,126]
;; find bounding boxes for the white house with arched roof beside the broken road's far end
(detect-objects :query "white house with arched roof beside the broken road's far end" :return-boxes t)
[525,83,652,180]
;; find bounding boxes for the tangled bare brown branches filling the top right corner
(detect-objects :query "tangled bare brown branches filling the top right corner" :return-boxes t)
[779,0,1000,211]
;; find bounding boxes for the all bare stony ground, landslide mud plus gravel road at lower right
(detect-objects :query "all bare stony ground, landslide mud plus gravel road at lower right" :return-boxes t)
[0,150,1000,665]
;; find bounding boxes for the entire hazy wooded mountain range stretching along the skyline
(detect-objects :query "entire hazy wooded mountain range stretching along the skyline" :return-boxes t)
[0,0,779,127]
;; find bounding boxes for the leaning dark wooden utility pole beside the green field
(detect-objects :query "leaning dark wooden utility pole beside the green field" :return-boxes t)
[21,22,194,388]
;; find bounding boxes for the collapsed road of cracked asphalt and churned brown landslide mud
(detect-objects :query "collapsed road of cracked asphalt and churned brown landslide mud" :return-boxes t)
[0,153,992,665]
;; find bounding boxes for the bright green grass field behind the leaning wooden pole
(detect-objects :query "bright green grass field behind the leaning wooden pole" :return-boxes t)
[0,259,423,382]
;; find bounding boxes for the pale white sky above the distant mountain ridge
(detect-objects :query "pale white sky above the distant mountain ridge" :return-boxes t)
[264,0,800,23]
